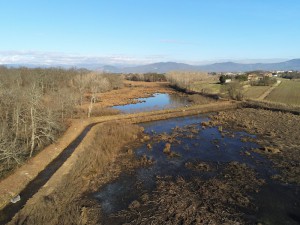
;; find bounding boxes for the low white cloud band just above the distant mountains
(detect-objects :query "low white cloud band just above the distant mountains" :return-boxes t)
[0,51,288,67]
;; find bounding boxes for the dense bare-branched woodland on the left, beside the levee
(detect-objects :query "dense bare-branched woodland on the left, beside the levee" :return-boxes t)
[0,67,122,177]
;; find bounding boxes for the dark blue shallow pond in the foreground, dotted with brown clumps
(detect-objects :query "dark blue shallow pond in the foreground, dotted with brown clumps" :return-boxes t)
[93,115,300,224]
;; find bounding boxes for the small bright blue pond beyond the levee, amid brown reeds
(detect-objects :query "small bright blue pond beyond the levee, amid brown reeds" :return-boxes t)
[112,93,189,113]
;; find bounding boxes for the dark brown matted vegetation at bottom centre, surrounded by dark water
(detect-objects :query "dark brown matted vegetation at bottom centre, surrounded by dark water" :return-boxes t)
[111,162,264,225]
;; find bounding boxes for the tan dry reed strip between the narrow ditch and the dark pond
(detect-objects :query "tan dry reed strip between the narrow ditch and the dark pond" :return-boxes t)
[9,122,142,224]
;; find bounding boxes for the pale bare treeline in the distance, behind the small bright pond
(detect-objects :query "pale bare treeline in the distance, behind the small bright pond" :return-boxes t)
[166,71,209,91]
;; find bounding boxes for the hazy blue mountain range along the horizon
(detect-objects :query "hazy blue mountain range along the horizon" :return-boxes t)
[6,59,300,73]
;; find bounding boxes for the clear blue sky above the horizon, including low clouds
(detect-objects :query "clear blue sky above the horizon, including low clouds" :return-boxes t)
[0,0,300,63]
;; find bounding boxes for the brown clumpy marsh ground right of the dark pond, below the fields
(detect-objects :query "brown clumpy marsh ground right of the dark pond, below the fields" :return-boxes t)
[212,108,300,184]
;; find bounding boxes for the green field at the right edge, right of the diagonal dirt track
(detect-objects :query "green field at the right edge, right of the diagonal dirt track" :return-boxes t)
[265,79,300,105]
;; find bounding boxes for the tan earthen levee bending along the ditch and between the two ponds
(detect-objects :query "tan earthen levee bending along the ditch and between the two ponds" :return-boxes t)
[0,101,241,213]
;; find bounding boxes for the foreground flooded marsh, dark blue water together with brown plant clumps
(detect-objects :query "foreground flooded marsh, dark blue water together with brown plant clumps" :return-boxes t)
[95,115,300,224]
